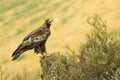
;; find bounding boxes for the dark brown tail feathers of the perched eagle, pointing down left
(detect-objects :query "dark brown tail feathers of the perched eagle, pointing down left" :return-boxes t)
[12,44,25,61]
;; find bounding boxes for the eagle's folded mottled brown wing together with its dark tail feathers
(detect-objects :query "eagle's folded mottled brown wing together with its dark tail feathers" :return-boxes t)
[12,28,48,60]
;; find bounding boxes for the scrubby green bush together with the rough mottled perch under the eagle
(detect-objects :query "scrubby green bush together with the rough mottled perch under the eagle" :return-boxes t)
[41,15,120,80]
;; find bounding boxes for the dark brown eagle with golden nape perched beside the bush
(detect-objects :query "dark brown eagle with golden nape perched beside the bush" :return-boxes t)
[12,18,53,60]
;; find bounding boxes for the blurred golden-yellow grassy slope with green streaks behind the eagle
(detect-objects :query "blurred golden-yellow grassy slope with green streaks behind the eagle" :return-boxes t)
[0,0,120,80]
